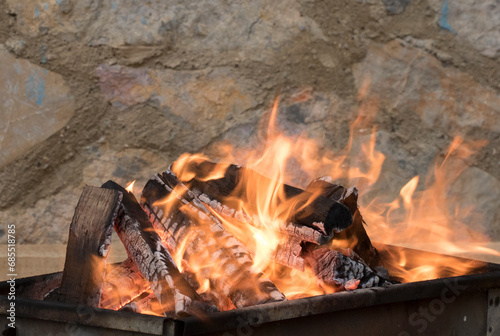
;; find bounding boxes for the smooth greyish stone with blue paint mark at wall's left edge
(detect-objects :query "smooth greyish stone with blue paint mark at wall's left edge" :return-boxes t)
[0,44,74,167]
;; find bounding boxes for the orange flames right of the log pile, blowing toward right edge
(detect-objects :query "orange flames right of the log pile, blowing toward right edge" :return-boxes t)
[362,137,500,282]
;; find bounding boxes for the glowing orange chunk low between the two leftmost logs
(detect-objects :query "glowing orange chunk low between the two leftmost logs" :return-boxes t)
[101,258,150,310]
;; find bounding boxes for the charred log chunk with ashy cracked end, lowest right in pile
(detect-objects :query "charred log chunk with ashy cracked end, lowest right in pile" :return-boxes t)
[306,248,394,290]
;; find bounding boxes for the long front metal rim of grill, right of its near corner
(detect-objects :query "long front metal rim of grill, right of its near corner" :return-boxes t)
[180,271,500,335]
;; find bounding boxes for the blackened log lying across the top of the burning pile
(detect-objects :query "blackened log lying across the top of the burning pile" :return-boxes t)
[172,161,352,243]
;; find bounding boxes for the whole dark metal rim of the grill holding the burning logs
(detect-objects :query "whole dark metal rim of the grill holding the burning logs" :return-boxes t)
[0,244,500,335]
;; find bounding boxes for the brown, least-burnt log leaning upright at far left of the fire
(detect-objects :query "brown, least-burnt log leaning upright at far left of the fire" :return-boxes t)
[57,186,122,307]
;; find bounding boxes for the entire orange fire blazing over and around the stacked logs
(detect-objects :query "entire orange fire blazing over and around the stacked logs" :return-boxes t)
[102,90,500,316]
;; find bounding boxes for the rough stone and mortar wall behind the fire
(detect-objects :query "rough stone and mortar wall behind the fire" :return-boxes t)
[0,0,500,244]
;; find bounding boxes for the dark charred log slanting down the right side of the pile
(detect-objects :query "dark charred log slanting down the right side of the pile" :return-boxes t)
[306,177,382,271]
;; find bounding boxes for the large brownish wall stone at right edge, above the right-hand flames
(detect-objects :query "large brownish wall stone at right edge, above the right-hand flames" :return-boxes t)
[354,40,500,136]
